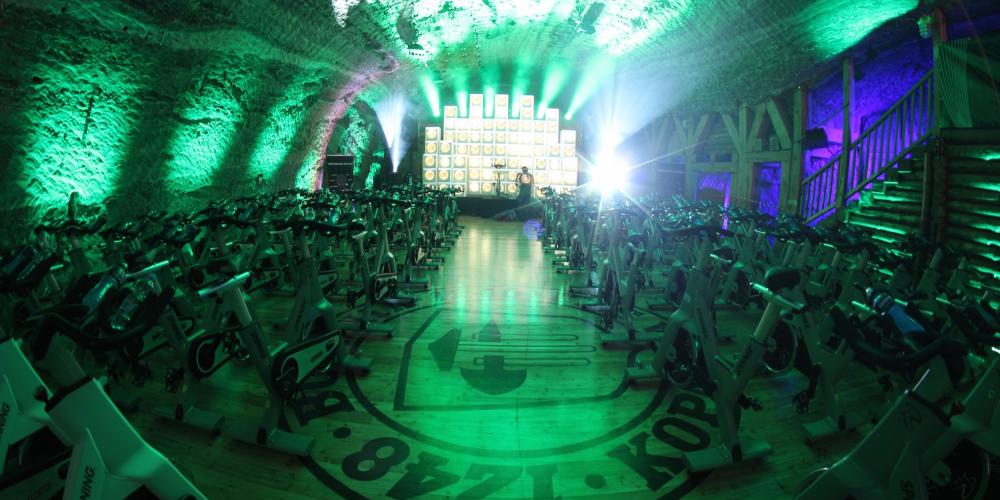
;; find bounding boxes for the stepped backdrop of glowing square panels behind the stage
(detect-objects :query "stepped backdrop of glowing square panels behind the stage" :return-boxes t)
[424,94,577,196]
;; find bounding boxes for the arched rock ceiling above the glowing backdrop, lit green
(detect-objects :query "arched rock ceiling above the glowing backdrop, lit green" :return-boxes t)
[127,0,1000,140]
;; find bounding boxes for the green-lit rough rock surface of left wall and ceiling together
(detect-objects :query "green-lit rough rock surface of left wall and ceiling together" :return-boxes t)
[0,0,940,241]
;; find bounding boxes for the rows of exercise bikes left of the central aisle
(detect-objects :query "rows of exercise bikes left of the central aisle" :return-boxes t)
[0,186,462,499]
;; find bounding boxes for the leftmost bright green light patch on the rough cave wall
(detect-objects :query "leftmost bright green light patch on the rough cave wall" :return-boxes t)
[17,51,144,215]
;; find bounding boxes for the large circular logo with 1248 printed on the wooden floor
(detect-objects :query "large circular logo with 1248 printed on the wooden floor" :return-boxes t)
[297,307,714,498]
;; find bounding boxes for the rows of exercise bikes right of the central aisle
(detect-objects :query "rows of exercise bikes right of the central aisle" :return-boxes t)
[539,188,1000,500]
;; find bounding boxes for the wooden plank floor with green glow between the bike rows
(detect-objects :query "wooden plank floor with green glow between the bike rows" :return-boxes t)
[132,218,884,499]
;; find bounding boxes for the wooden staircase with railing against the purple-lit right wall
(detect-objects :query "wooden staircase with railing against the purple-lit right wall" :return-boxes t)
[799,65,1000,296]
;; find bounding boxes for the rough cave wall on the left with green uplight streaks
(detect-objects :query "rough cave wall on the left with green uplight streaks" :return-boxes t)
[0,0,357,240]
